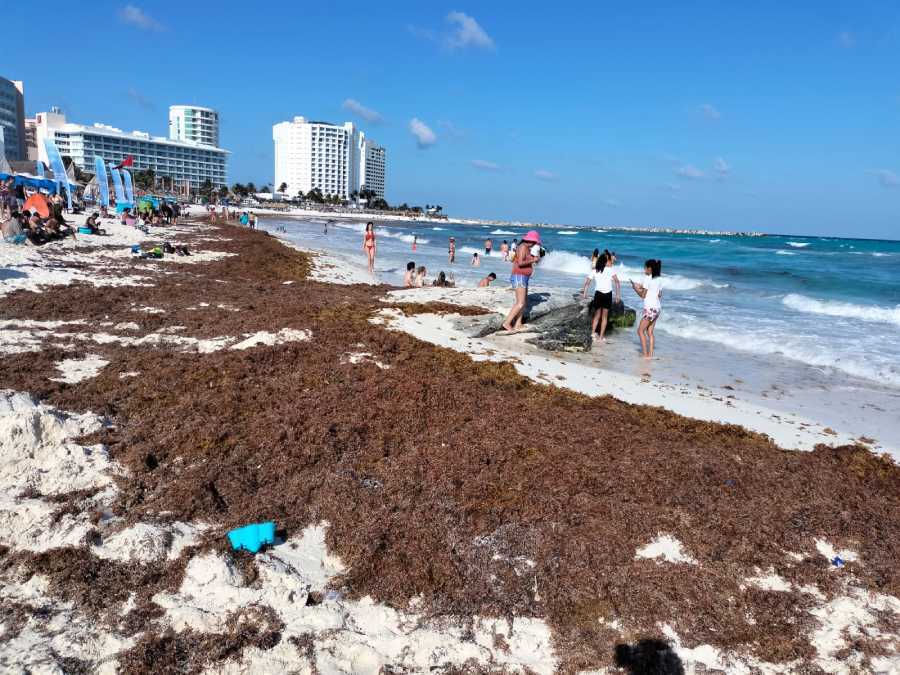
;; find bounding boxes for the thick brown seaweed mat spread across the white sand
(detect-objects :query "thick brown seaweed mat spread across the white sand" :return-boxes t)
[0,219,900,672]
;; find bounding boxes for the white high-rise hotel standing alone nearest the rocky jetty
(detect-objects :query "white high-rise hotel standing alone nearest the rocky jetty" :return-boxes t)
[272,117,385,199]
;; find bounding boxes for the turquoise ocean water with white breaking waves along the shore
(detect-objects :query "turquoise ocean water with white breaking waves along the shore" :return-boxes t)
[263,218,900,389]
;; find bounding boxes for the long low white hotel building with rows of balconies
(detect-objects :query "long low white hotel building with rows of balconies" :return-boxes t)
[35,108,229,192]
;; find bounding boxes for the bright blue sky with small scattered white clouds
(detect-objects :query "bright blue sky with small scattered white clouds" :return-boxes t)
[7,0,900,238]
